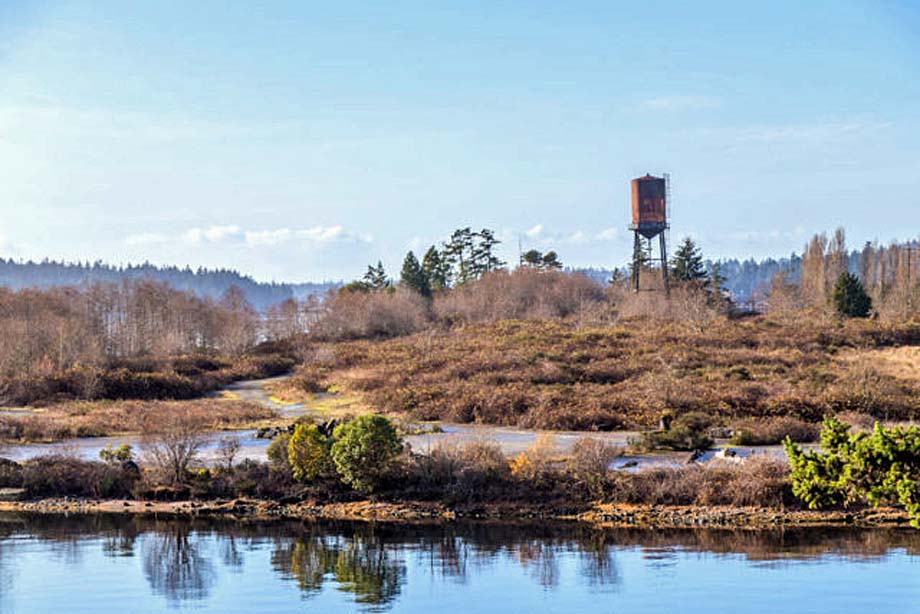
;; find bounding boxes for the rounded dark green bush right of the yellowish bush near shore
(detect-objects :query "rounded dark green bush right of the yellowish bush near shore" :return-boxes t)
[331,415,403,492]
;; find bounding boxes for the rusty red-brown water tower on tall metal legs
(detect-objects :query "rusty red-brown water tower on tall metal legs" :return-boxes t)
[629,174,671,293]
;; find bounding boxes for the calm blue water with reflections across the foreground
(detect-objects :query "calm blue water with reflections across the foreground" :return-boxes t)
[0,515,920,613]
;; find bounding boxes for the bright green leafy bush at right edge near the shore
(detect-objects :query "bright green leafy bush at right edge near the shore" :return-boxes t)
[783,418,920,528]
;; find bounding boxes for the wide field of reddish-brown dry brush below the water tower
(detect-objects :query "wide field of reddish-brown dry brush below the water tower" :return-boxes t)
[294,316,920,430]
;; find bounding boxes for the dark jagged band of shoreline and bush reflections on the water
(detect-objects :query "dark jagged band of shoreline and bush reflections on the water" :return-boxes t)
[0,514,920,611]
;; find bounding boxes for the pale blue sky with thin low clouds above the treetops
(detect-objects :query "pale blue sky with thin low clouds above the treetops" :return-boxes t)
[0,0,920,281]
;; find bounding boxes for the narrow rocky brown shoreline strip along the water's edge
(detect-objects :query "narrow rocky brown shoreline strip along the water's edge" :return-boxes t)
[0,498,909,530]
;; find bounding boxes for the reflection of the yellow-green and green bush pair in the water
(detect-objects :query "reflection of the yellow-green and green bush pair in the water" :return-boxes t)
[272,531,406,606]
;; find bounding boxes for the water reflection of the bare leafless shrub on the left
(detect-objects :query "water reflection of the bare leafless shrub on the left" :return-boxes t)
[141,523,216,604]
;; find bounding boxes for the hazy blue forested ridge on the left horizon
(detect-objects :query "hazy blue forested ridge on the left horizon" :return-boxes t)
[0,258,341,311]
